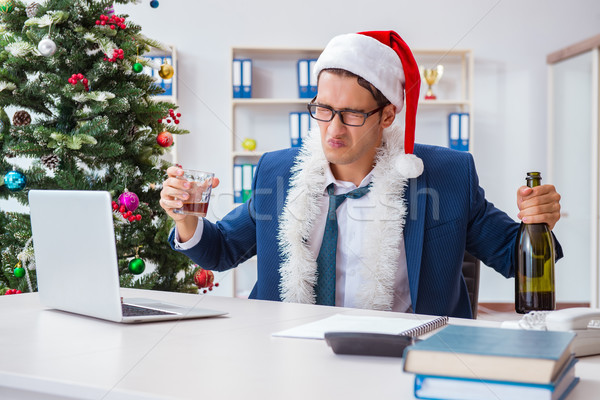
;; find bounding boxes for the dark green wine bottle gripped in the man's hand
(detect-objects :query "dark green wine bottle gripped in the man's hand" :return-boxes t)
[515,172,556,314]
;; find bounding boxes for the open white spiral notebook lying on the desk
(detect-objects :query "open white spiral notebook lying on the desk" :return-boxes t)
[273,314,448,339]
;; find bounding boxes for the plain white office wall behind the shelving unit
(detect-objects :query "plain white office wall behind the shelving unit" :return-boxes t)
[4,0,600,302]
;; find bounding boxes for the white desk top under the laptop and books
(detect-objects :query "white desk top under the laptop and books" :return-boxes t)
[0,289,600,400]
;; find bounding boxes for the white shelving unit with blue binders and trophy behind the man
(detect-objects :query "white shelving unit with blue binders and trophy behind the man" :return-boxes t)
[230,47,474,297]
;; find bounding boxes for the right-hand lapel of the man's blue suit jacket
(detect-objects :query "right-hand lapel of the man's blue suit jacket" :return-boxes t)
[404,174,427,311]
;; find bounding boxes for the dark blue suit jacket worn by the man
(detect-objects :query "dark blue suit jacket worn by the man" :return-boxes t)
[169,144,562,318]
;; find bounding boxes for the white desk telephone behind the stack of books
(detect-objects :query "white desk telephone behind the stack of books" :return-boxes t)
[503,307,600,357]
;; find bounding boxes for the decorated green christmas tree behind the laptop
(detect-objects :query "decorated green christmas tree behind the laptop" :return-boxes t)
[0,0,197,294]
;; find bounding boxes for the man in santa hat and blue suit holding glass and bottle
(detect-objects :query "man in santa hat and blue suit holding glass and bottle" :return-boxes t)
[161,31,561,317]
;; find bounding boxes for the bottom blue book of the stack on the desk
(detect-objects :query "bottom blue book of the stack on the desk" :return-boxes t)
[414,356,579,400]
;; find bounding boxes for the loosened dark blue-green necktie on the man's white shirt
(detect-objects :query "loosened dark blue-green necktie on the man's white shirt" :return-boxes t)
[315,183,371,306]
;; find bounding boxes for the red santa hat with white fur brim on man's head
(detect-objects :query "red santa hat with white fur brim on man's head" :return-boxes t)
[313,31,421,154]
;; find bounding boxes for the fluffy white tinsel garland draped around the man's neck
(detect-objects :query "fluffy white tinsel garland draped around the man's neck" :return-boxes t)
[278,124,423,310]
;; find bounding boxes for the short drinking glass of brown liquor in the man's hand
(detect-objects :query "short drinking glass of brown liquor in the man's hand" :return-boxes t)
[173,169,215,217]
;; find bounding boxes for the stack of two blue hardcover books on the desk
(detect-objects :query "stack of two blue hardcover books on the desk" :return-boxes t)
[404,325,579,400]
